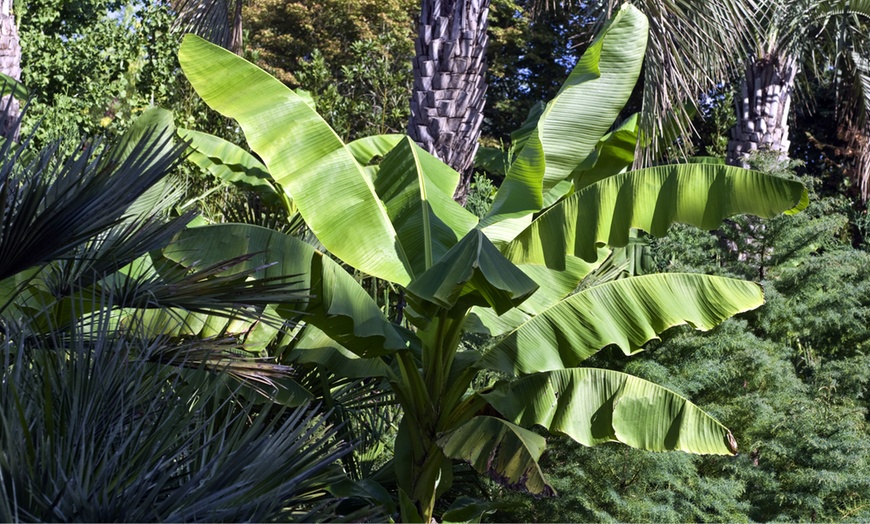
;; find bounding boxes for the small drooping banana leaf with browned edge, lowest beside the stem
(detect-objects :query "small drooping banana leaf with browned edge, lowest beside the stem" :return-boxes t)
[438,416,556,497]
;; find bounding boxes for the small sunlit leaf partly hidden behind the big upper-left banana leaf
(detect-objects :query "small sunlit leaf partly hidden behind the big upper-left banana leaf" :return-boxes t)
[178,129,286,203]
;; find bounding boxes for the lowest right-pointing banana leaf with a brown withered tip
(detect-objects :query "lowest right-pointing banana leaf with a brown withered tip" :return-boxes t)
[483,368,737,455]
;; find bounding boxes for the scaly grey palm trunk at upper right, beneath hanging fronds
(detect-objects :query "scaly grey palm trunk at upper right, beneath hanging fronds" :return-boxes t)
[727,53,798,167]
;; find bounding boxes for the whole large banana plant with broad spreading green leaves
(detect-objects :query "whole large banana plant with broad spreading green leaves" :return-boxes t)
[177,5,807,522]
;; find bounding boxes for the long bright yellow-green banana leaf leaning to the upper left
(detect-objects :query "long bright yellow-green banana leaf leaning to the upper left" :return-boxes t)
[178,35,411,285]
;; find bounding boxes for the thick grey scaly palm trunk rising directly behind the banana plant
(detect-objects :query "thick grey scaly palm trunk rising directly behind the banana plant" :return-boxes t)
[408,0,489,204]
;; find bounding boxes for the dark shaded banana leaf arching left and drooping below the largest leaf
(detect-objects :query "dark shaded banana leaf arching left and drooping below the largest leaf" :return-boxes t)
[163,224,406,356]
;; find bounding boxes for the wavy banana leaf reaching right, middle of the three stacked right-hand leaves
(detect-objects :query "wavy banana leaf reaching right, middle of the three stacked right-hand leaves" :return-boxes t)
[478,273,764,374]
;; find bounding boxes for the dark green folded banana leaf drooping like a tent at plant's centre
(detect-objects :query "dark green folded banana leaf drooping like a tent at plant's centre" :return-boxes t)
[407,229,538,318]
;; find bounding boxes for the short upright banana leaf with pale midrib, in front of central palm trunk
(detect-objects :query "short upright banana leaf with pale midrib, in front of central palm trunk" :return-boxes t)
[374,137,477,278]
